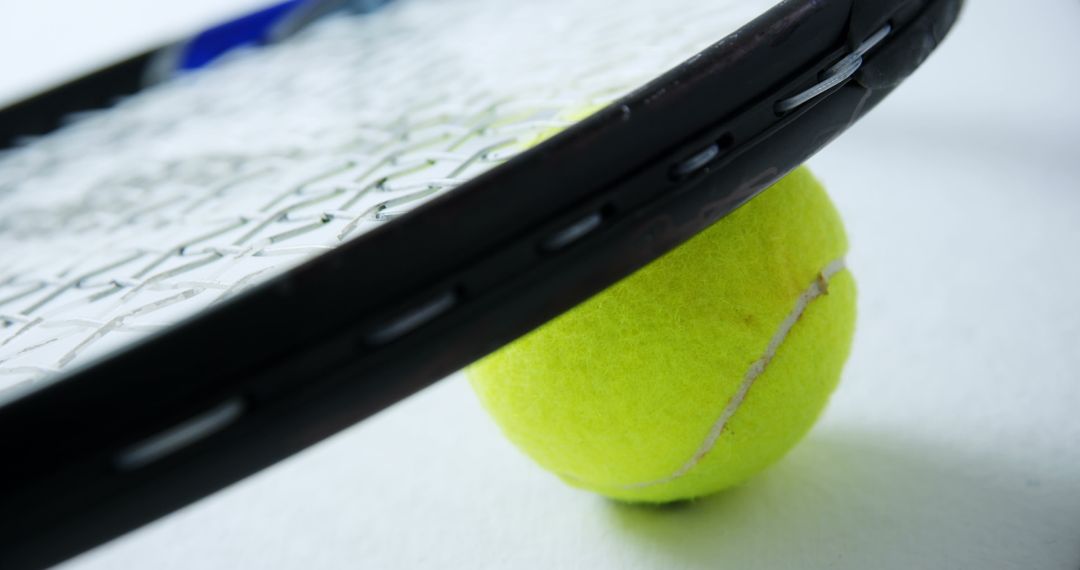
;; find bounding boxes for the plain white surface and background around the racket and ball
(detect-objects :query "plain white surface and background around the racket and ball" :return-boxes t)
[0,0,1080,570]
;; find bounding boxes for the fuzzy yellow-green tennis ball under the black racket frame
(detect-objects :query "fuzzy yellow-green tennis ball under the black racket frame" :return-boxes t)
[467,168,855,502]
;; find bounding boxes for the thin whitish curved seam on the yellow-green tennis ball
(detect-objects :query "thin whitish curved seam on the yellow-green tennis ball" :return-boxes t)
[622,258,846,489]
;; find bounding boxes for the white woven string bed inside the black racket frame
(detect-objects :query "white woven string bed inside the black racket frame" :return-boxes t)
[0,0,772,391]
